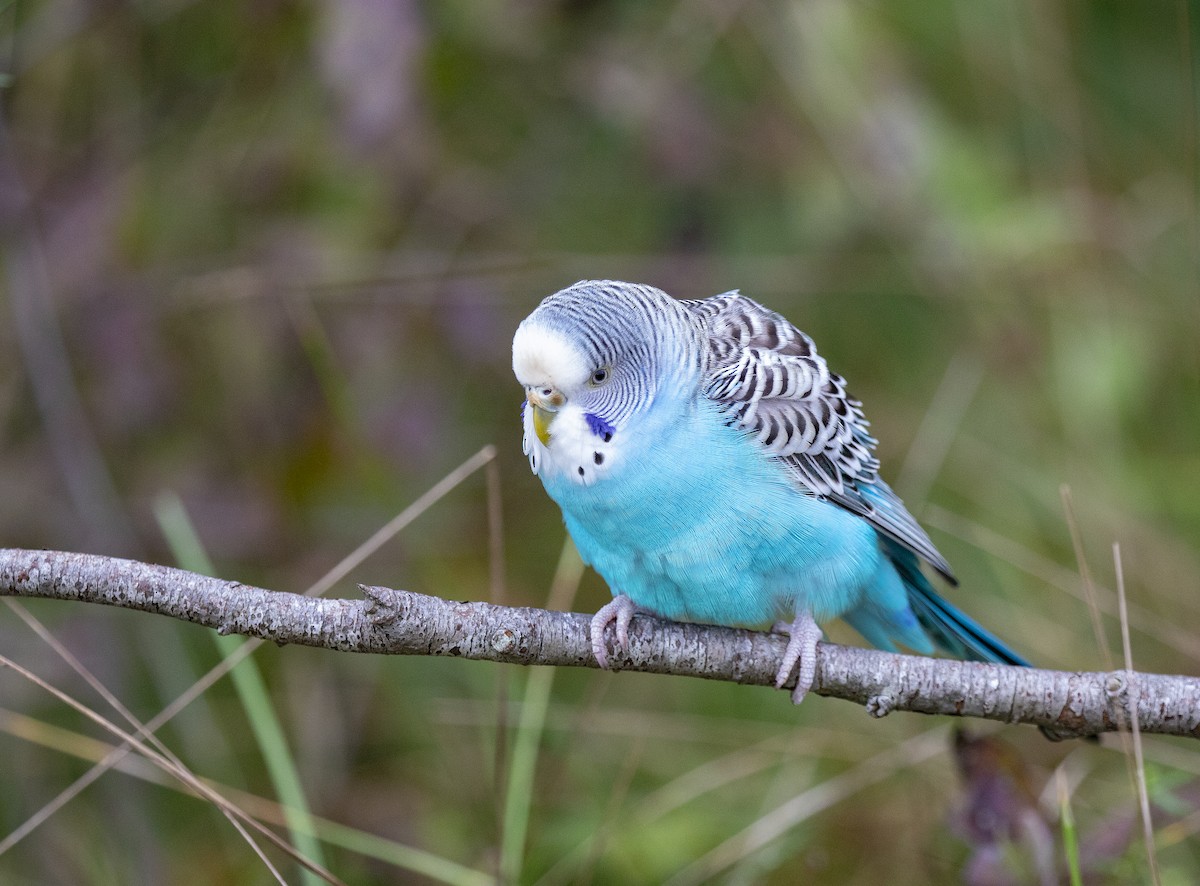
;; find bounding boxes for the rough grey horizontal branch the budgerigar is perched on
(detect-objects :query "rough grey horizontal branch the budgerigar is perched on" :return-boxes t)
[0,549,1200,738]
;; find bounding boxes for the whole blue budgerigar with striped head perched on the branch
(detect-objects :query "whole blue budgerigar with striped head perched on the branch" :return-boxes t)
[512,281,1025,704]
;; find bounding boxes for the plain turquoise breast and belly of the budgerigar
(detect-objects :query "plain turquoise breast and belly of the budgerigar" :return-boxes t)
[544,405,888,628]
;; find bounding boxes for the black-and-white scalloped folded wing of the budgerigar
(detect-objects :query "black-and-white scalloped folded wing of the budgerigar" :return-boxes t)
[682,291,956,583]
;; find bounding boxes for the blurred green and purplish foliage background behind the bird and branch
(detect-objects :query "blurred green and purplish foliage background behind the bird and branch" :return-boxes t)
[0,0,1200,884]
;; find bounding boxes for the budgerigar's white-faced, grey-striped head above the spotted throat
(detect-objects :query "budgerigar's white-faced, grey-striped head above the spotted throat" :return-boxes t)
[512,280,682,445]
